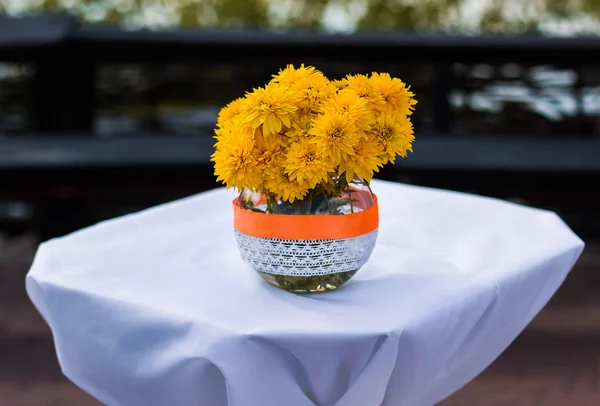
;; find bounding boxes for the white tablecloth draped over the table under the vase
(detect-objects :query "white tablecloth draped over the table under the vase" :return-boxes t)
[27,182,583,406]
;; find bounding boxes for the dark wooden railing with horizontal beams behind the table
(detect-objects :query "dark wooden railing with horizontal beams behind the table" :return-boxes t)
[0,15,600,238]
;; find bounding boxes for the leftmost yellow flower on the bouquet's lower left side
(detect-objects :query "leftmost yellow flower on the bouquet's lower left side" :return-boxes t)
[211,122,261,190]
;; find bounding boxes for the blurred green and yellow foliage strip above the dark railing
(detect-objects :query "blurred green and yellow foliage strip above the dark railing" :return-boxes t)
[0,0,600,35]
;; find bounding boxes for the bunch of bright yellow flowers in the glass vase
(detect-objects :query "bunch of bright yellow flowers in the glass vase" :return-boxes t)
[211,65,416,214]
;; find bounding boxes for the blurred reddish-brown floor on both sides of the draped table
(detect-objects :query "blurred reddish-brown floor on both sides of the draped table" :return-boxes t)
[0,235,600,406]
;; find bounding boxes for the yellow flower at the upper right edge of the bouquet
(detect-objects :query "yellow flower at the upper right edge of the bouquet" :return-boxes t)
[369,72,417,116]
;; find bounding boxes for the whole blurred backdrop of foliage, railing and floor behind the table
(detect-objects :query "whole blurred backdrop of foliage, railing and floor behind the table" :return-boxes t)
[0,0,600,406]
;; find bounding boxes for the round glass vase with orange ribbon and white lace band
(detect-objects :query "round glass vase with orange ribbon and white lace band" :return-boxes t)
[233,183,379,293]
